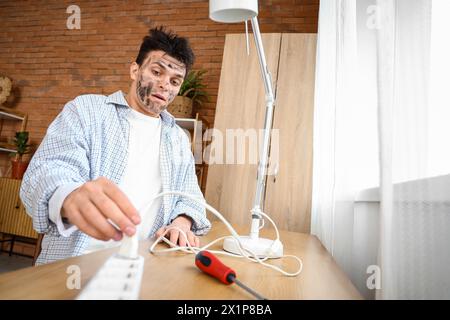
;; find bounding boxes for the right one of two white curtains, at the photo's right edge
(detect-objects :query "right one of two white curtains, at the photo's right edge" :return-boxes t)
[377,0,450,299]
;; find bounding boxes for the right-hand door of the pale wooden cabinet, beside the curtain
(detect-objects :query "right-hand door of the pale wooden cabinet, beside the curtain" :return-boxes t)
[264,33,317,233]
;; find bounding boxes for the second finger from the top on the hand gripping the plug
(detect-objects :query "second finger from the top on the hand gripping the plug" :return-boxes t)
[90,193,136,237]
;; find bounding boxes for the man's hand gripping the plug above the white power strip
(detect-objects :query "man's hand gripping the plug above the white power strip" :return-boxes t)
[61,177,141,241]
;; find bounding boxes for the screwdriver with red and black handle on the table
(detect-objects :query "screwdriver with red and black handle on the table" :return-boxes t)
[195,250,267,300]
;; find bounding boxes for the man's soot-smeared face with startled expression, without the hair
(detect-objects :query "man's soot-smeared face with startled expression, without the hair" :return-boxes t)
[131,51,186,115]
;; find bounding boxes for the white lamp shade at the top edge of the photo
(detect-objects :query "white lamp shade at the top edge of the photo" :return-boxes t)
[209,0,258,23]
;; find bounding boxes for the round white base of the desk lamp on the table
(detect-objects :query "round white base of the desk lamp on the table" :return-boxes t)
[223,236,283,259]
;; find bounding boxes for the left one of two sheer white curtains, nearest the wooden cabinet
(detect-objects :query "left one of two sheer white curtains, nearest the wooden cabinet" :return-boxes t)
[311,0,379,282]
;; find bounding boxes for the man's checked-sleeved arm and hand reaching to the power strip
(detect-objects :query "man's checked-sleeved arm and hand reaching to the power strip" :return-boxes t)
[20,102,140,240]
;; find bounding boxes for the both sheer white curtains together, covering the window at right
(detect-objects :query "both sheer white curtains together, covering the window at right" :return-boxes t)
[311,0,450,299]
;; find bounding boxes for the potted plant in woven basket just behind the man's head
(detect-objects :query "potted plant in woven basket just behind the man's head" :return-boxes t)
[168,70,209,118]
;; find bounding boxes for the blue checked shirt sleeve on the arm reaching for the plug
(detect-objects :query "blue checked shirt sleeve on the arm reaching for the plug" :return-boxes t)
[20,101,90,233]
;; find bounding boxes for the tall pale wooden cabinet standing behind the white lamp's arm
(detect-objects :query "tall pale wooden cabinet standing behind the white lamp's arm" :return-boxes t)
[206,34,316,232]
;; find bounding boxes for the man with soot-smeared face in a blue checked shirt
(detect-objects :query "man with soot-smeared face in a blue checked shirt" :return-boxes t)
[20,27,211,264]
